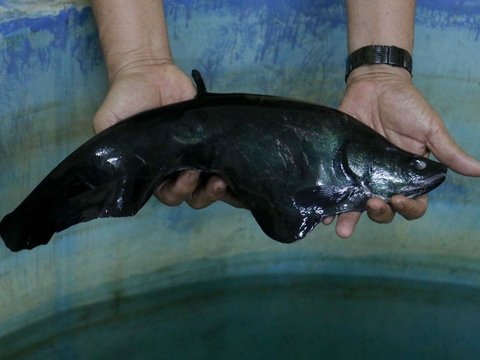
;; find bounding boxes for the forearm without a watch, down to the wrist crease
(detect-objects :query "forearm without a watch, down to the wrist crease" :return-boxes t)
[92,0,172,81]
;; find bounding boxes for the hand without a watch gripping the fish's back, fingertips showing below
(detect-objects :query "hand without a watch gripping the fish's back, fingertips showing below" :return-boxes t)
[94,61,241,209]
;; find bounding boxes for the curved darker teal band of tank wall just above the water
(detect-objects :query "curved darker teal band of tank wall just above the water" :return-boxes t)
[0,253,480,339]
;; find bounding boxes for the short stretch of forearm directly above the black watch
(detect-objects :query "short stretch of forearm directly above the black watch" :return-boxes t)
[346,0,415,54]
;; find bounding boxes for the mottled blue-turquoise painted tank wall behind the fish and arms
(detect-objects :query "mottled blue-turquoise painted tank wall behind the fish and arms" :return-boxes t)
[0,0,480,358]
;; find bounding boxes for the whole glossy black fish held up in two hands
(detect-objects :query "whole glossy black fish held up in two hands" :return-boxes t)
[0,71,446,251]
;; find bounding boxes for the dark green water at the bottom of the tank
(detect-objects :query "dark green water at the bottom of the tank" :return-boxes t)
[0,275,480,360]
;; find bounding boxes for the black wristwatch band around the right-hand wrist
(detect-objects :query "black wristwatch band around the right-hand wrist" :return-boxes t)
[345,45,412,82]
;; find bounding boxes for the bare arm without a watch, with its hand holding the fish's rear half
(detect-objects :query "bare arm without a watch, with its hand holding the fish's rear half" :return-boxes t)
[92,0,239,208]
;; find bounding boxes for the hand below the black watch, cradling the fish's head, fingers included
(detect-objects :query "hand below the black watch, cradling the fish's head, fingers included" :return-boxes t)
[324,65,480,238]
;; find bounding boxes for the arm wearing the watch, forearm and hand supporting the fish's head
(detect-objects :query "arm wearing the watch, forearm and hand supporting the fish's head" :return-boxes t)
[327,0,480,237]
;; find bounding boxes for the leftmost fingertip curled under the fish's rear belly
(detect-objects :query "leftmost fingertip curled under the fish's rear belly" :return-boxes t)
[155,170,200,206]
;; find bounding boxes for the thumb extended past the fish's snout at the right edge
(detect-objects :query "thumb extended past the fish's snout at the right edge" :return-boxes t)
[427,114,480,176]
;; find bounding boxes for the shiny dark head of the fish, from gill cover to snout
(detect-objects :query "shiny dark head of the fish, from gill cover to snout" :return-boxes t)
[344,141,447,201]
